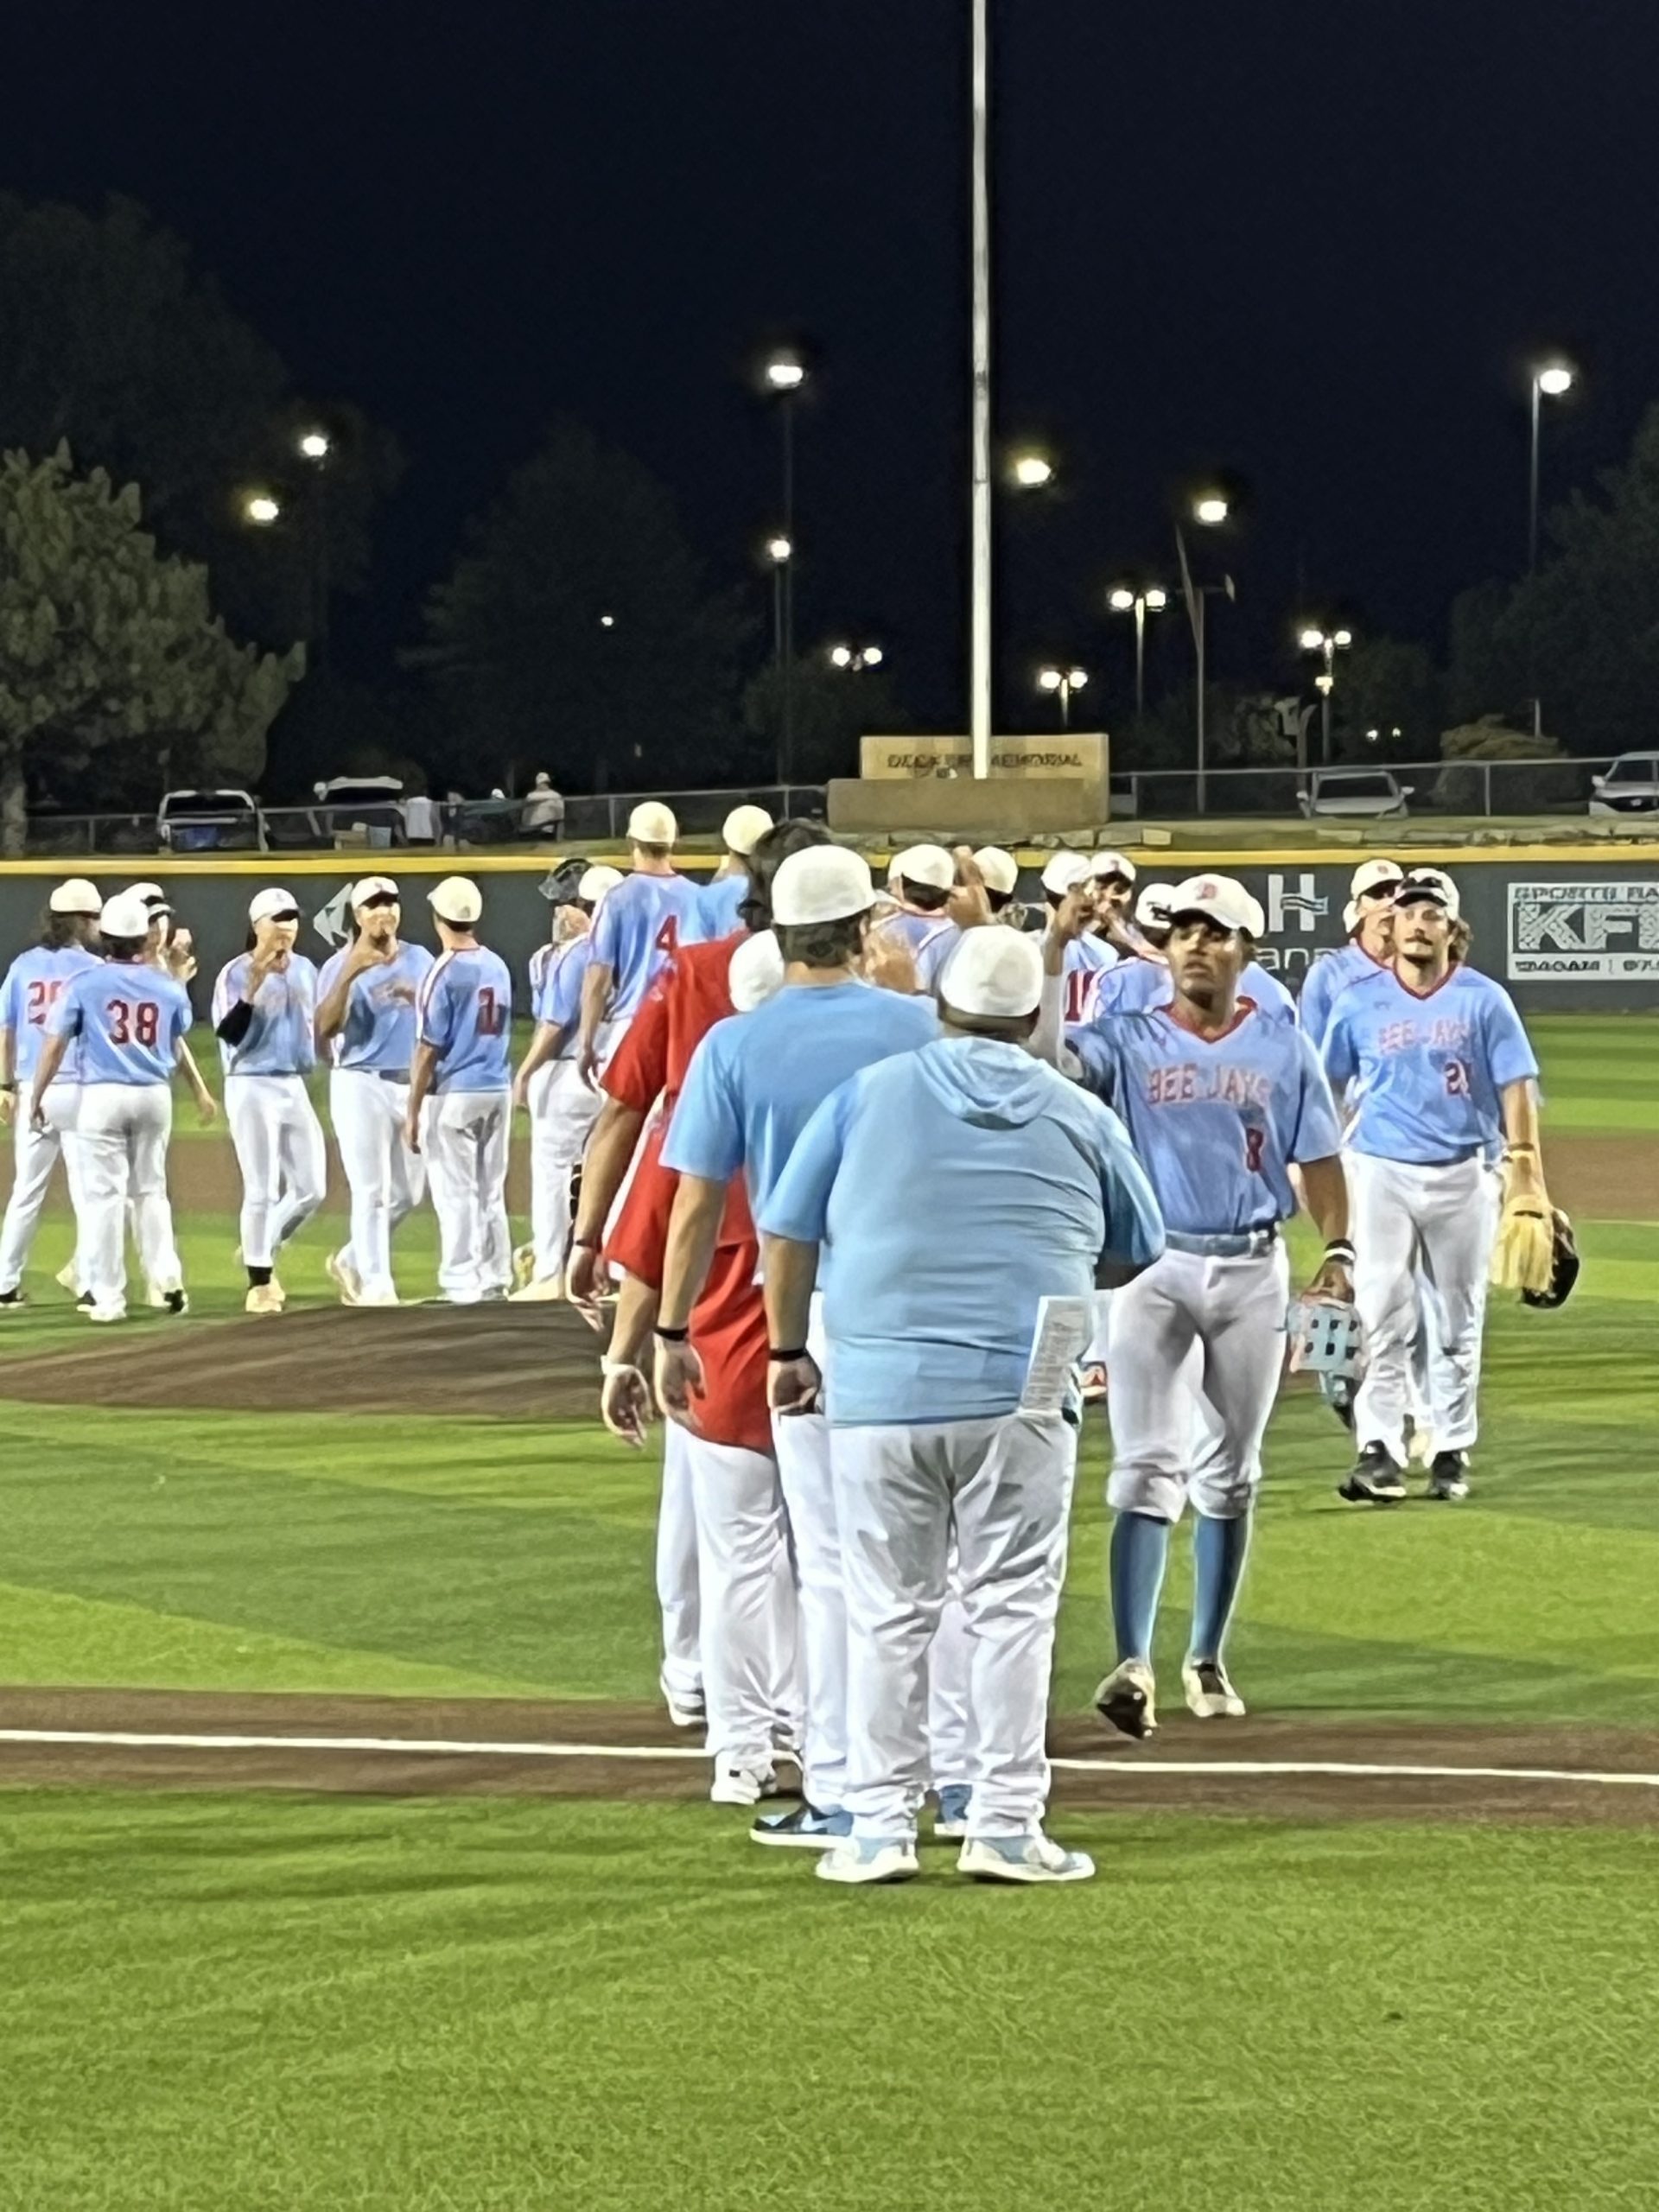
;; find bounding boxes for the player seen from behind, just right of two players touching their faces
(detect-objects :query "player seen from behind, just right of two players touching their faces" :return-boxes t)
[403,876,513,1305]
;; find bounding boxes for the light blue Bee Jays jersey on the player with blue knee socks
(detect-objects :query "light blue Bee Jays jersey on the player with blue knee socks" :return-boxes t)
[1068,1008,1343,1236]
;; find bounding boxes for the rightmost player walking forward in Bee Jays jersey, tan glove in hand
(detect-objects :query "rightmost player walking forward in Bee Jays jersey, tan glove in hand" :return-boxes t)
[1325,872,1548,1502]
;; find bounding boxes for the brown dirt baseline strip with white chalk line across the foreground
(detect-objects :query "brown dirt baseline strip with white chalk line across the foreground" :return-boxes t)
[0,1688,1659,1827]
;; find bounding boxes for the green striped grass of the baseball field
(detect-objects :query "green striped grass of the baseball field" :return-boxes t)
[0,1020,1659,2212]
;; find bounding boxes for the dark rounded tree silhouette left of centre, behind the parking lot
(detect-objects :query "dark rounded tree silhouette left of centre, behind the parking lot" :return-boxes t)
[410,423,747,791]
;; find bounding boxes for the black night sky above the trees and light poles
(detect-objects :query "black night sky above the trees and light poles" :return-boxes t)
[13,0,1659,726]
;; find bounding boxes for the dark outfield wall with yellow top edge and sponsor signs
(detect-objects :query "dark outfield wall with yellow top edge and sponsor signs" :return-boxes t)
[0,845,1659,1013]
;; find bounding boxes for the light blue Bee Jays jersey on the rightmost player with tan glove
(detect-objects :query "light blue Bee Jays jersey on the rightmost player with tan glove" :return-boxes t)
[1325,964,1537,1166]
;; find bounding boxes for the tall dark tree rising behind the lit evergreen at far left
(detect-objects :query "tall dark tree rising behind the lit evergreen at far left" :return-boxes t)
[0,194,398,644]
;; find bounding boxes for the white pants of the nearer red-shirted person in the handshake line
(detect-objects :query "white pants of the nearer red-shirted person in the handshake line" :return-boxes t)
[681,1429,801,1772]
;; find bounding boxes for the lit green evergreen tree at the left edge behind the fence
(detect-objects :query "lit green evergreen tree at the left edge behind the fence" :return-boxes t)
[0,445,305,854]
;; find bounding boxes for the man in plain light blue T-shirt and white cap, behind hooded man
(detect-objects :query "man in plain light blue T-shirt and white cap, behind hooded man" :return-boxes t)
[657,845,946,1845]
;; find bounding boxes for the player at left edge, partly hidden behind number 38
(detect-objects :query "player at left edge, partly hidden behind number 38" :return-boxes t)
[0,876,102,1314]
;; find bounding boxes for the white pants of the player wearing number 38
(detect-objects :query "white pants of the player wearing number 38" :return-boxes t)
[74,1084,183,1307]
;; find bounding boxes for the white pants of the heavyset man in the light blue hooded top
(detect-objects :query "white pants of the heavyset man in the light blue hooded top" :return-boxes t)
[830,1414,1077,1840]
